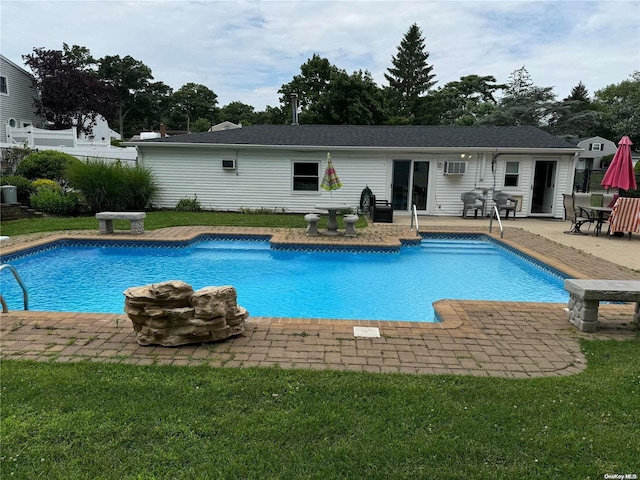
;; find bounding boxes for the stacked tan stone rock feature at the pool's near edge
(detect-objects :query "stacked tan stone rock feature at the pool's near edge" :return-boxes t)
[124,280,249,347]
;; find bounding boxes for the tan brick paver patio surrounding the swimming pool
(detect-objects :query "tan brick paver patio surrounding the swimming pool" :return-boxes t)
[0,224,640,378]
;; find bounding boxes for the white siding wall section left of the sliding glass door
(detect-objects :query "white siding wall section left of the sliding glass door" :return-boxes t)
[139,146,387,213]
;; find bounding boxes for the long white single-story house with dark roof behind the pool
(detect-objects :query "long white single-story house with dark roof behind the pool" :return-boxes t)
[129,125,579,218]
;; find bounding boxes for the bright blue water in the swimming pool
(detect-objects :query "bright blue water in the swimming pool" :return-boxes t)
[1,236,568,322]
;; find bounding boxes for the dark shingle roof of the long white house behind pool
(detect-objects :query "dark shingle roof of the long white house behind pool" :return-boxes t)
[136,125,575,149]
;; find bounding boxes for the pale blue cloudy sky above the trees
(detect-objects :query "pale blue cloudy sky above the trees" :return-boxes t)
[0,0,640,111]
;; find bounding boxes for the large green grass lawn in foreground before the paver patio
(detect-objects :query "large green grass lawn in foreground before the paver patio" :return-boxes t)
[0,339,640,479]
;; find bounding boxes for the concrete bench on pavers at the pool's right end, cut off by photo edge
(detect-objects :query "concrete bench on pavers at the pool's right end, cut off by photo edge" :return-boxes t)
[564,279,640,332]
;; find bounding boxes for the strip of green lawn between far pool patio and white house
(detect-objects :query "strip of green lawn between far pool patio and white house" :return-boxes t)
[0,210,367,236]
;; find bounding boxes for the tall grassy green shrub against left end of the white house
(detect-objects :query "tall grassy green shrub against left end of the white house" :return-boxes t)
[67,160,158,212]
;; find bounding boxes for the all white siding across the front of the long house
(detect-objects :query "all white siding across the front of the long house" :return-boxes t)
[139,145,573,220]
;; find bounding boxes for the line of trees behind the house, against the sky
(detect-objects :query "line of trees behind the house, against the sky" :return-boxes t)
[23,24,640,148]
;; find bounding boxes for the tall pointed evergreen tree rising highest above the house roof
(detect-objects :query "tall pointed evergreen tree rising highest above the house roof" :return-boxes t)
[384,23,436,121]
